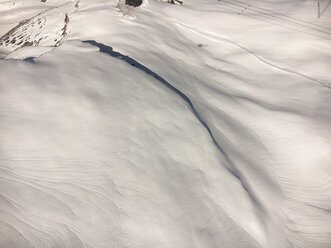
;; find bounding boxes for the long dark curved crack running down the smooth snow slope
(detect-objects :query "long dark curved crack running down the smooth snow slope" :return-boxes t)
[82,40,261,206]
